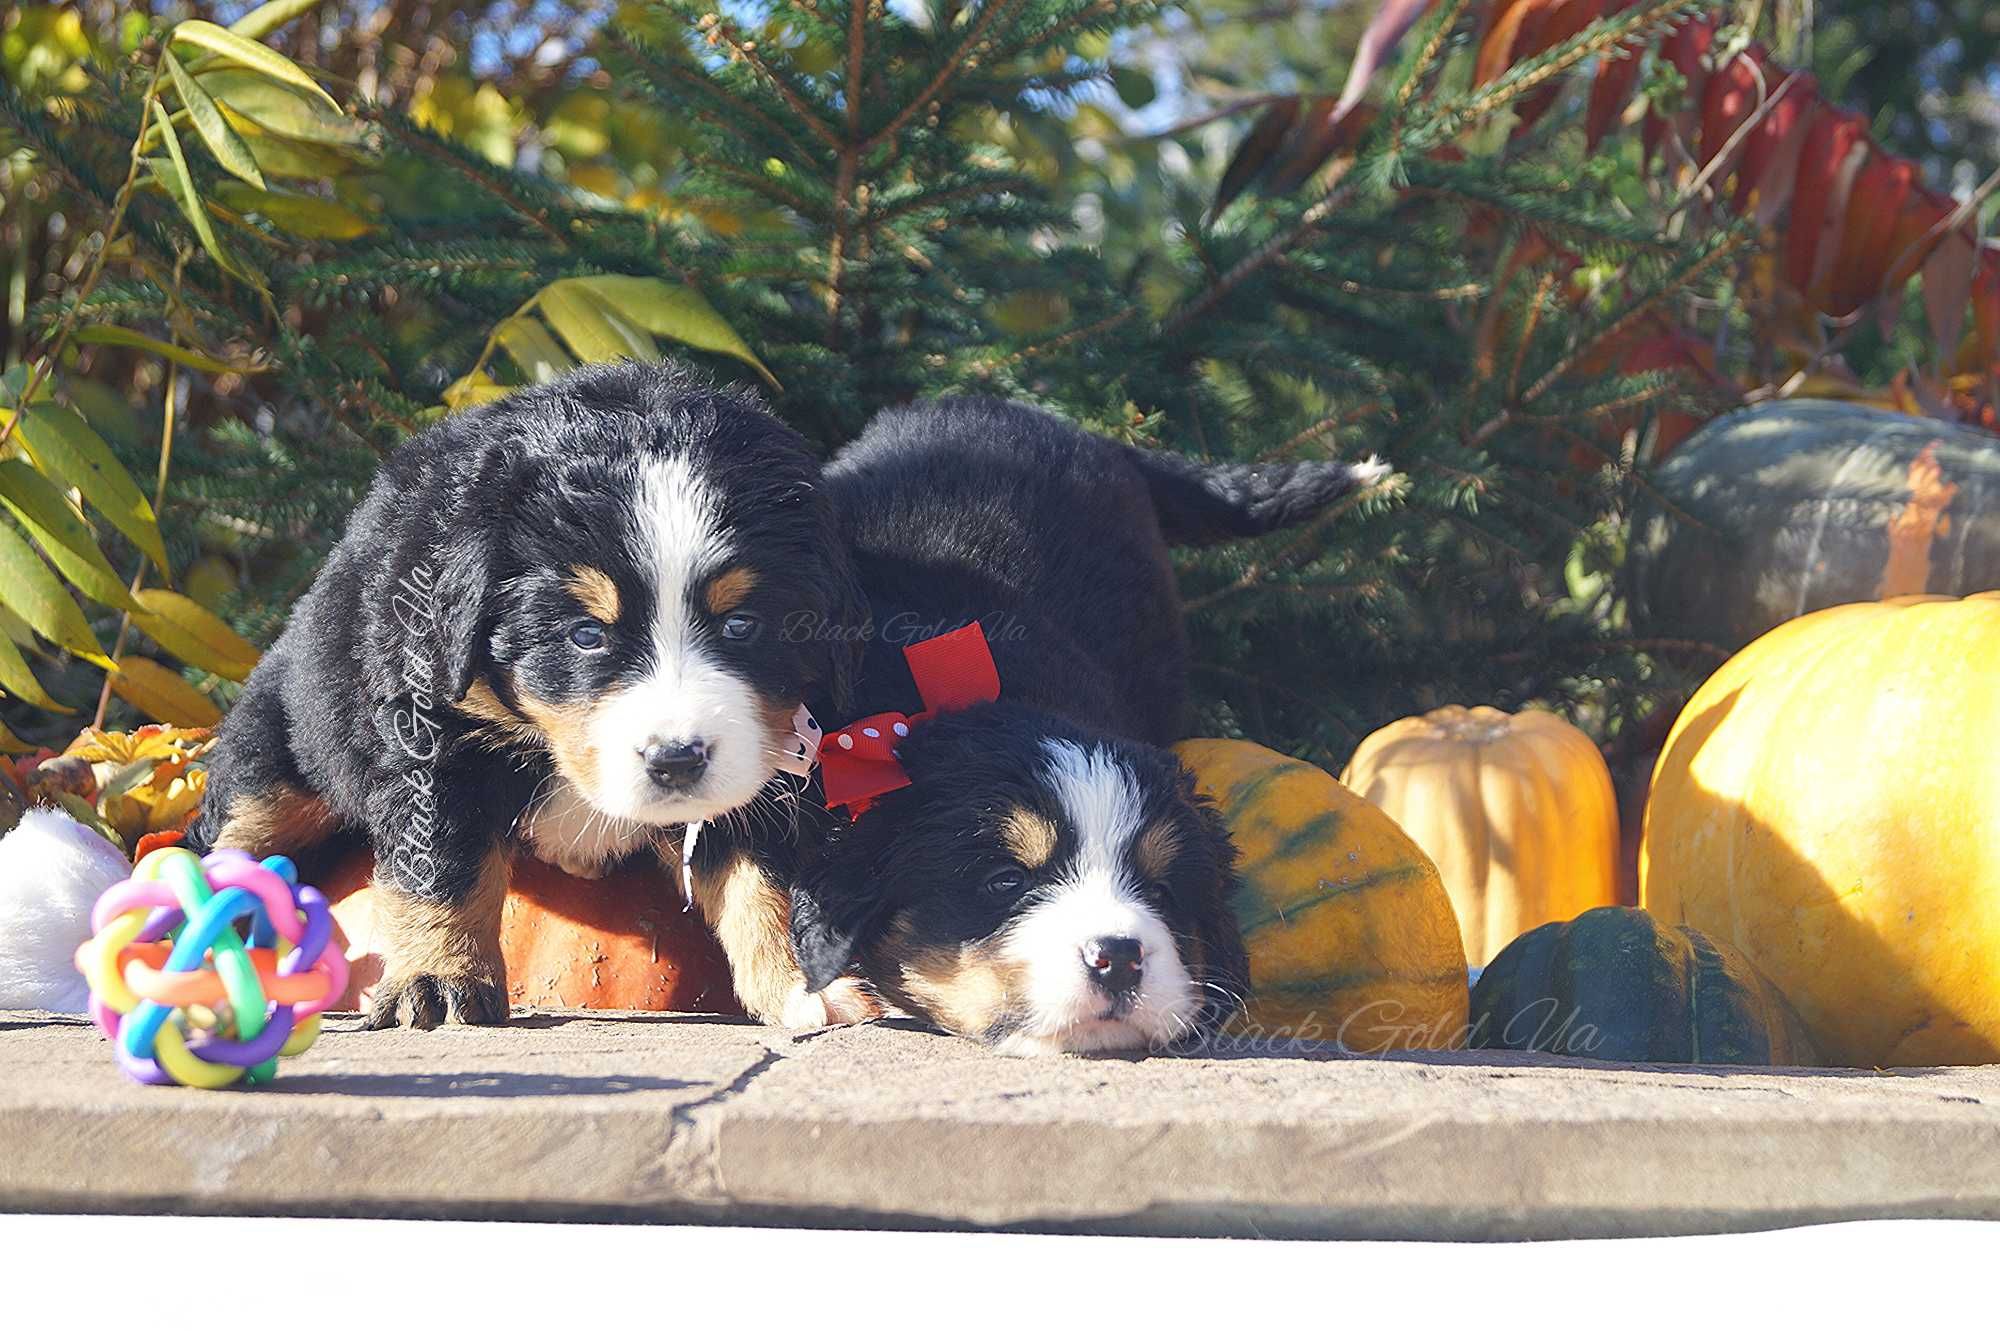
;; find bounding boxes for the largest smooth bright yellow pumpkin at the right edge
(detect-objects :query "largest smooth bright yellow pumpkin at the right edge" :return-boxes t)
[1640,594,2000,1067]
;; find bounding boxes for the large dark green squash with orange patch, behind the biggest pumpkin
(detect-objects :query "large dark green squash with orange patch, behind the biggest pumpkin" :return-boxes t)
[1624,402,2000,652]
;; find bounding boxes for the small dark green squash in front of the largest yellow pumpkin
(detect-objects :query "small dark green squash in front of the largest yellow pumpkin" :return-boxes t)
[1468,905,1820,1067]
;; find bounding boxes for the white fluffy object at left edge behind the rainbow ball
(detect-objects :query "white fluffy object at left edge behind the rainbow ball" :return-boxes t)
[0,809,132,1011]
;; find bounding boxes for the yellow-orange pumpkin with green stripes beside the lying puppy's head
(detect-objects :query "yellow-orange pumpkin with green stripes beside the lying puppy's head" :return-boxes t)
[1174,739,1466,1053]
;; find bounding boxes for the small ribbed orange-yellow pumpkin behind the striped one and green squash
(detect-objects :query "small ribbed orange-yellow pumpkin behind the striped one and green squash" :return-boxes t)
[1340,707,1618,965]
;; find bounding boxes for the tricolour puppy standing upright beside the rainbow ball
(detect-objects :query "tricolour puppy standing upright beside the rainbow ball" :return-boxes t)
[192,364,864,1027]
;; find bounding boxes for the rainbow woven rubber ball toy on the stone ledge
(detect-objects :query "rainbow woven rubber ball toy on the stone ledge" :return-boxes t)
[76,845,348,1089]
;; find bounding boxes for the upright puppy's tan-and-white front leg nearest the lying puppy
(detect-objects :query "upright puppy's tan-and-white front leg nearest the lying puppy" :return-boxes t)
[694,855,882,1029]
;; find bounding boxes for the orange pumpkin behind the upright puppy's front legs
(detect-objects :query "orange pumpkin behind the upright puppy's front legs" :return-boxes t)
[320,851,742,1015]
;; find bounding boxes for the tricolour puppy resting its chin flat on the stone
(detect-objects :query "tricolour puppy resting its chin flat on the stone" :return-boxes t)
[792,400,1388,1053]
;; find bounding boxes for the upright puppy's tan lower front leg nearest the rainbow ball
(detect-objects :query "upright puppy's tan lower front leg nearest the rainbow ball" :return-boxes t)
[368,843,512,1031]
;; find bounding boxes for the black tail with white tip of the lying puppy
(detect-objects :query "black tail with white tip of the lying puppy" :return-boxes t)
[1130,450,1394,546]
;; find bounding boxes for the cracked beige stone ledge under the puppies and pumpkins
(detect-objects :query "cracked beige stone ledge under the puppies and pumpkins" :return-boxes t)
[0,1011,2000,1239]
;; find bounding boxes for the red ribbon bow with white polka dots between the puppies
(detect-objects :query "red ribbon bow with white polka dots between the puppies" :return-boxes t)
[820,622,1000,817]
